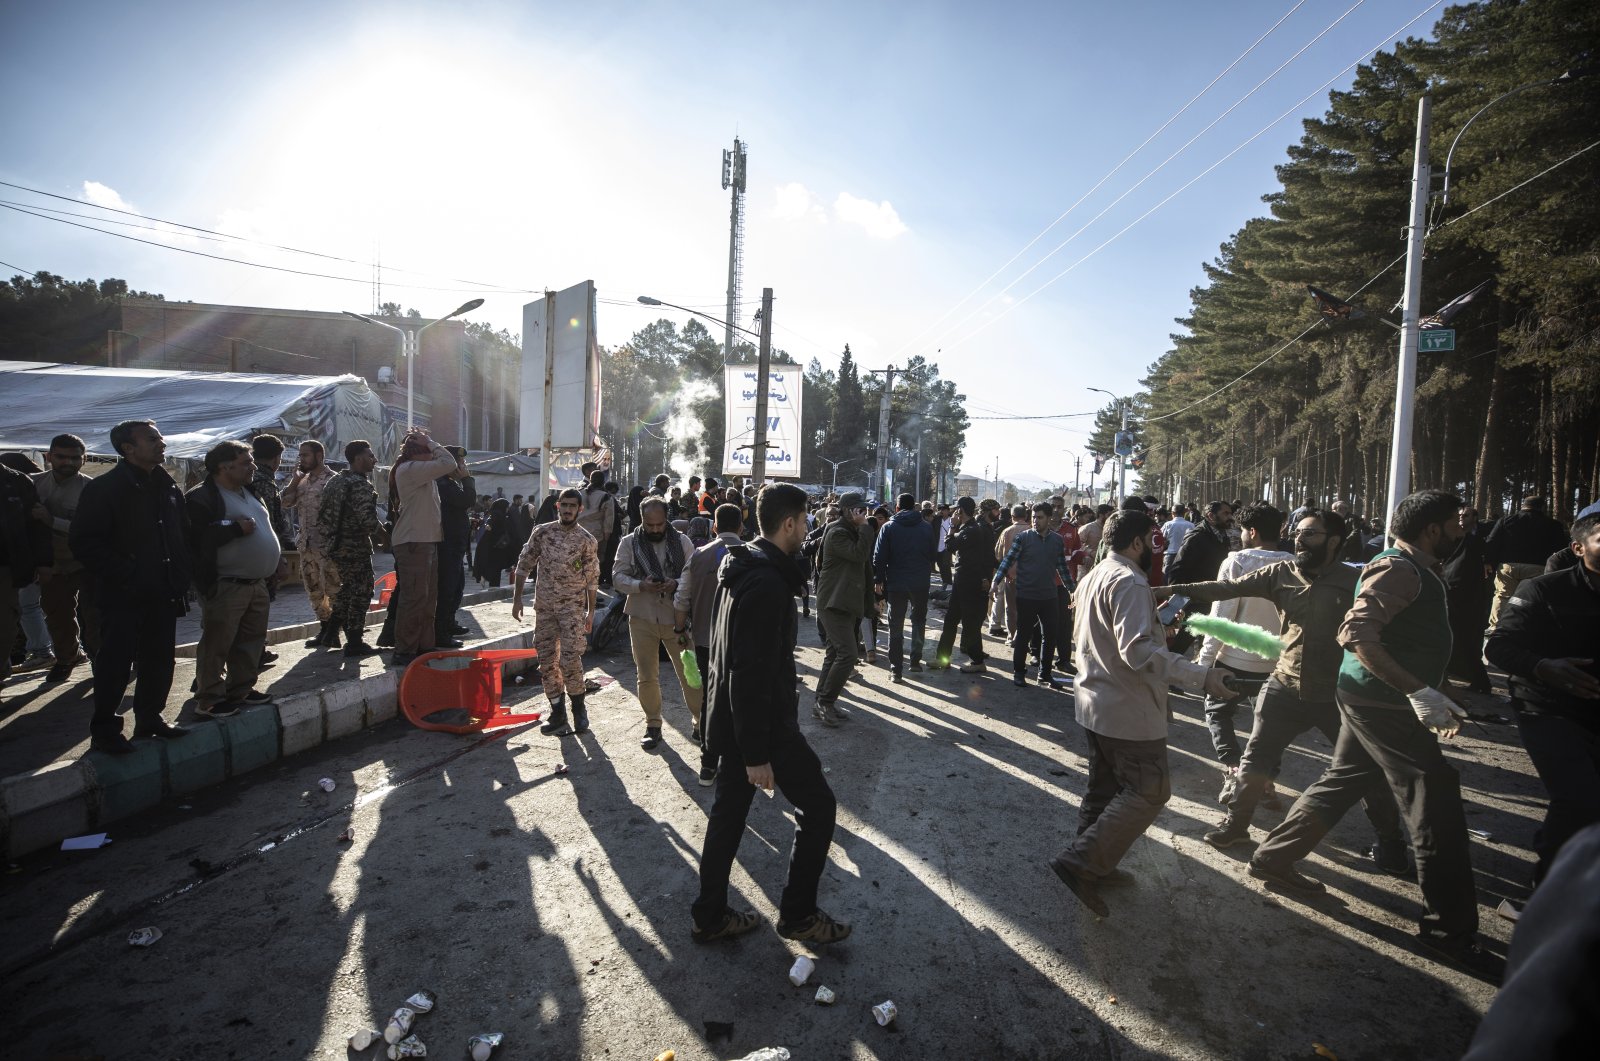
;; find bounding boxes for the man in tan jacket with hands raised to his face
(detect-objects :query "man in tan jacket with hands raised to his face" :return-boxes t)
[389,427,456,667]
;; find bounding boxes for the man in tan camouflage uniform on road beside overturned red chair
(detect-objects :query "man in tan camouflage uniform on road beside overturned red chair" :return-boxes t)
[510,490,600,736]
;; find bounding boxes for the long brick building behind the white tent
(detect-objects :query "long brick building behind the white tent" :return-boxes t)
[104,298,522,453]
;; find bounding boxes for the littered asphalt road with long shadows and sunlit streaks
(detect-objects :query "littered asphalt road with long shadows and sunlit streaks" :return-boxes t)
[0,613,1542,1061]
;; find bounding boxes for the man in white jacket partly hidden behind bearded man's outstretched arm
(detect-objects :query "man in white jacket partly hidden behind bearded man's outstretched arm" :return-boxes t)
[1195,501,1294,807]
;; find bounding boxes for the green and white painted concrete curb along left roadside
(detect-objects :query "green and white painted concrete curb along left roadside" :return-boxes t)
[0,627,534,859]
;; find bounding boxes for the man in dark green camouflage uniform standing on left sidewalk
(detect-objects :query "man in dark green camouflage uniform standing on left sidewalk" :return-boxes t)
[317,442,384,656]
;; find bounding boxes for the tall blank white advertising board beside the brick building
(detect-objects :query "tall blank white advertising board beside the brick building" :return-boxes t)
[517,280,600,450]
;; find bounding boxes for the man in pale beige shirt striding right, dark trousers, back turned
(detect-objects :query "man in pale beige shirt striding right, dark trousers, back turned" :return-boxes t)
[1050,510,1230,917]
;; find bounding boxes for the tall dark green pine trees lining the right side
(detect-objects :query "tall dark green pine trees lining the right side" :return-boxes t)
[1113,0,1600,514]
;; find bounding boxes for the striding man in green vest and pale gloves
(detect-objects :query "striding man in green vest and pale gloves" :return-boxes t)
[1250,490,1483,967]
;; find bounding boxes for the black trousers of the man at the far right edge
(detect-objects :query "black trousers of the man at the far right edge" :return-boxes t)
[1512,699,1600,883]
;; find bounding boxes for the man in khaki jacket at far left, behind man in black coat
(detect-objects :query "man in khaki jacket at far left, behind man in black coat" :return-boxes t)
[34,435,99,685]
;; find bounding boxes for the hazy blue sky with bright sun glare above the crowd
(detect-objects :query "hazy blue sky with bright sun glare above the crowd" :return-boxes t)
[0,0,1442,482]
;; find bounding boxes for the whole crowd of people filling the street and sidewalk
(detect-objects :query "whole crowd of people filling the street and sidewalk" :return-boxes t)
[0,421,1600,1004]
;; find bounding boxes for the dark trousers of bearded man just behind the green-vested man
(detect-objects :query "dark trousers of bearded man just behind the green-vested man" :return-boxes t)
[1206,680,1405,842]
